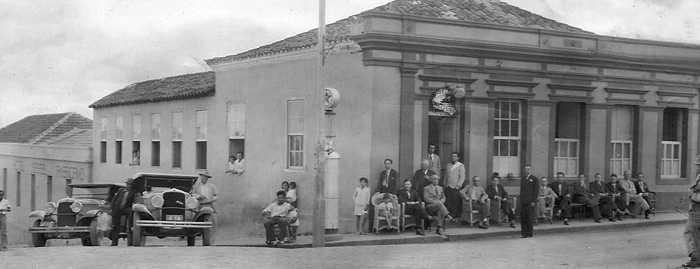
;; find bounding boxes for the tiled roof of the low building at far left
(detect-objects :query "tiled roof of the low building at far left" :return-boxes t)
[0,112,92,144]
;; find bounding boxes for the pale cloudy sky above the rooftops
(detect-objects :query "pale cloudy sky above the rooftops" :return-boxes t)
[0,0,700,127]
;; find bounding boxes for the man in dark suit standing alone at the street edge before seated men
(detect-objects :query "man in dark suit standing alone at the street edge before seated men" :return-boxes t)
[520,164,540,238]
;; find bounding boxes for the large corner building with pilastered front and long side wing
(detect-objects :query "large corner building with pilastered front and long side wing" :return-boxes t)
[92,0,700,236]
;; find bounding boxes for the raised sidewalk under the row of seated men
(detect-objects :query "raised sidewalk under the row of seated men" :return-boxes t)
[216,212,688,248]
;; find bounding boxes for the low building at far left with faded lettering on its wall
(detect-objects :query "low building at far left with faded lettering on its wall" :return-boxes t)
[0,112,92,245]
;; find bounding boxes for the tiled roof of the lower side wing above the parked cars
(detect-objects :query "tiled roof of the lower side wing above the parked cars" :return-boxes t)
[89,71,215,108]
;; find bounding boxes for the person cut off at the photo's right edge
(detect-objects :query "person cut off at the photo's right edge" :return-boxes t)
[682,156,700,268]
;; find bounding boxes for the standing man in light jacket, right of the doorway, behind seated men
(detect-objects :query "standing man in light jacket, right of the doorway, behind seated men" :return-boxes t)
[445,152,466,218]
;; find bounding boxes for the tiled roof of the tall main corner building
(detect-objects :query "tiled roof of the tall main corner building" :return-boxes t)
[206,0,591,65]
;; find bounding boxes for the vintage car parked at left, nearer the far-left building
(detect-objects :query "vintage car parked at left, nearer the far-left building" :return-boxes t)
[29,183,125,247]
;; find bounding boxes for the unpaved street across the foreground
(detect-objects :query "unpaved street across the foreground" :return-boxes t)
[0,225,687,269]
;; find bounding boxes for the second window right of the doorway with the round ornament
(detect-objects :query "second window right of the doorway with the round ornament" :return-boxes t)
[553,102,581,177]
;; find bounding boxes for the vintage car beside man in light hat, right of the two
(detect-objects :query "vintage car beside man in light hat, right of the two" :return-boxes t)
[130,173,214,246]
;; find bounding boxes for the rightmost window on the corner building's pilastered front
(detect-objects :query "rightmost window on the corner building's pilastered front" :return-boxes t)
[661,107,688,178]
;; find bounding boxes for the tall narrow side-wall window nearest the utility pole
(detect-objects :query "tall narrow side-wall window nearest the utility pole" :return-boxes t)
[287,100,305,168]
